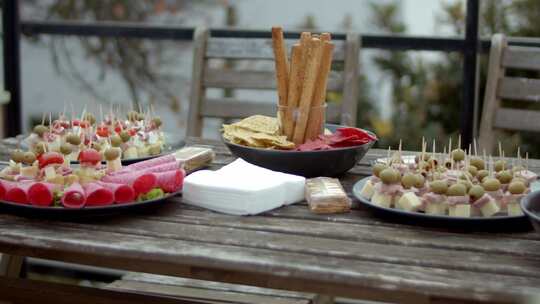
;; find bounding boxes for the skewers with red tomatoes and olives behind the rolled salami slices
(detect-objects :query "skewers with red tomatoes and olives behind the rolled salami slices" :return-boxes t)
[25,105,165,165]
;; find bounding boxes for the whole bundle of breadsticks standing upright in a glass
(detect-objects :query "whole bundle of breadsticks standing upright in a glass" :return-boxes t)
[272,27,334,145]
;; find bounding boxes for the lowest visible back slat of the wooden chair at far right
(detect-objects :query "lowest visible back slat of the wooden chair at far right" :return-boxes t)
[494,108,540,132]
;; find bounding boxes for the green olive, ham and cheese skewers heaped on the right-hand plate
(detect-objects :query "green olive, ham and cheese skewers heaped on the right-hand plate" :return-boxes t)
[361,139,537,217]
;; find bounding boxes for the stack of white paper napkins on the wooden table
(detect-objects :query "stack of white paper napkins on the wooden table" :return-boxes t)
[182,159,306,215]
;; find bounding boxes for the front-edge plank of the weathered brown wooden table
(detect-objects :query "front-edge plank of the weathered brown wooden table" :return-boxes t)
[0,220,540,301]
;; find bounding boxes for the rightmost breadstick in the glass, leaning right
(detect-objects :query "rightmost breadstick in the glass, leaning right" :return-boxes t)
[305,41,334,140]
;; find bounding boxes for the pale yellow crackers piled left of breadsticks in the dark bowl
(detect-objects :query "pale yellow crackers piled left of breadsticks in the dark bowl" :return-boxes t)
[223,115,295,150]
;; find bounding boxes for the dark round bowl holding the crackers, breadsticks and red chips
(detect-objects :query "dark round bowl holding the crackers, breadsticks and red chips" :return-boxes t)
[223,124,374,177]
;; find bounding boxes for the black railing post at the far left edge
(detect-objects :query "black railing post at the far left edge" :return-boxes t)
[2,0,22,136]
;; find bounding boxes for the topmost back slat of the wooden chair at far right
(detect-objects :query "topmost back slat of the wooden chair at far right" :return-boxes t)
[502,46,540,71]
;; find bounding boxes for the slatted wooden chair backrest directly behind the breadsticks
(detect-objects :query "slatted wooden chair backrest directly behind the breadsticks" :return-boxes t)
[187,28,360,136]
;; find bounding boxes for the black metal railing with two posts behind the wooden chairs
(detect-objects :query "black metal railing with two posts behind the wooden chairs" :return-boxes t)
[3,0,538,146]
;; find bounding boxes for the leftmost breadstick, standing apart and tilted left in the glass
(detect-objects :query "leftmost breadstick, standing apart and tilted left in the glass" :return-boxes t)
[272,27,289,119]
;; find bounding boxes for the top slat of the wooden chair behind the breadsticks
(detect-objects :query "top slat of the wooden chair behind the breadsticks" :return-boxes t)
[206,38,345,61]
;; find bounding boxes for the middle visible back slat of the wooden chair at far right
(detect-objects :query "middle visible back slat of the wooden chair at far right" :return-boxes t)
[497,77,540,102]
